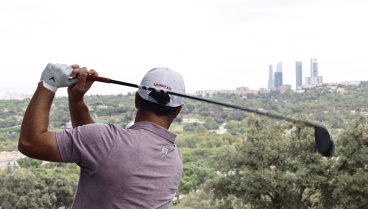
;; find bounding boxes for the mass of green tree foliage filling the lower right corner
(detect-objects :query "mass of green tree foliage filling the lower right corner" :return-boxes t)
[183,117,368,208]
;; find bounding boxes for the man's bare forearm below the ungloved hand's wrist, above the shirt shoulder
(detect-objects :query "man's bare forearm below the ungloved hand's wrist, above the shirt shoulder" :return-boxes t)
[69,97,95,128]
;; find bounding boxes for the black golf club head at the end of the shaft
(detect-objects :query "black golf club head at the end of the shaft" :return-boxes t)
[314,126,335,157]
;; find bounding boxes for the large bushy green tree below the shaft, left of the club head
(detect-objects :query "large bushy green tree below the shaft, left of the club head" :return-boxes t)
[205,117,333,208]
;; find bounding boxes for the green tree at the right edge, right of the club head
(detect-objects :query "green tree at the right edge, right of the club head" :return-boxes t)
[331,116,368,208]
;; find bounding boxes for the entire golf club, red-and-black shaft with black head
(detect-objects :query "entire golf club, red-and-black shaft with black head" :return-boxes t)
[87,75,335,157]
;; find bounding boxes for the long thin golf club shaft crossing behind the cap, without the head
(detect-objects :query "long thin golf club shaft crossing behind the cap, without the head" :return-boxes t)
[87,75,324,128]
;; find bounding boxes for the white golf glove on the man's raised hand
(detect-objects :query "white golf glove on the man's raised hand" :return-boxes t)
[38,63,79,92]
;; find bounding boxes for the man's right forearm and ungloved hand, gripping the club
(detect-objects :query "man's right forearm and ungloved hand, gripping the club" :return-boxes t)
[68,65,98,128]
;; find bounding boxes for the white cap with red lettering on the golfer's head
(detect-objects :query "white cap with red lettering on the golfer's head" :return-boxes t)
[138,67,185,107]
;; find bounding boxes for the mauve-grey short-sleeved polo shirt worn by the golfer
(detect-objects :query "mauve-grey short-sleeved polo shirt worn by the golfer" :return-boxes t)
[56,122,183,209]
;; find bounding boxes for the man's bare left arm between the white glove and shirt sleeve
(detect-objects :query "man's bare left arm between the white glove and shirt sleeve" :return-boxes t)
[18,82,63,162]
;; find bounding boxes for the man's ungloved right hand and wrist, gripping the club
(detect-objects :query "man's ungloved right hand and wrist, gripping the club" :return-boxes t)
[68,65,98,102]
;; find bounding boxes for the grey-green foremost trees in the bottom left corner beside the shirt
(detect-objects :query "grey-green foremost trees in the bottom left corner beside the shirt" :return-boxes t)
[0,173,77,209]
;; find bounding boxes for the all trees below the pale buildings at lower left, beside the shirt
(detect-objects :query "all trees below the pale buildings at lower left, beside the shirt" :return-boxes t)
[0,158,80,209]
